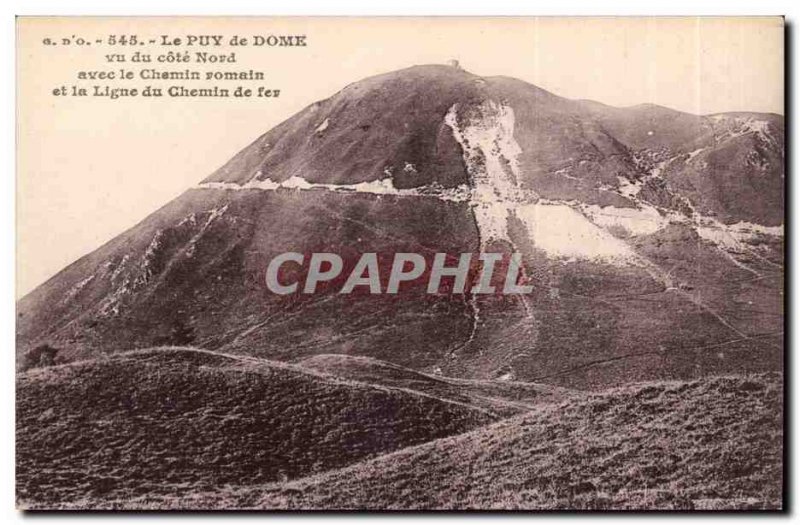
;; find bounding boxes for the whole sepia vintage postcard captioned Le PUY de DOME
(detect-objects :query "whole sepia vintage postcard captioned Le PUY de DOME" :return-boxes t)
[16,17,785,511]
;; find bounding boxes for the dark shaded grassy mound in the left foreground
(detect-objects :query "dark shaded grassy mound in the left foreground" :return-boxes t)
[16,348,496,508]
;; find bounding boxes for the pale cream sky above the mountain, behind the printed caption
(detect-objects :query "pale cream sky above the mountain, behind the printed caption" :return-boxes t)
[17,18,784,297]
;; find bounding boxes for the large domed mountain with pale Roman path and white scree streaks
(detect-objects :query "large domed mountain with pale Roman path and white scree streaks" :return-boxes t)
[17,66,784,388]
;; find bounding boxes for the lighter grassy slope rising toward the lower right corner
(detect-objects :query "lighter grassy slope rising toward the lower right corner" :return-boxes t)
[111,374,782,509]
